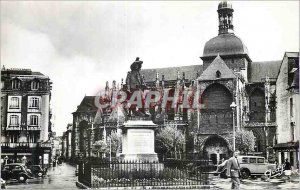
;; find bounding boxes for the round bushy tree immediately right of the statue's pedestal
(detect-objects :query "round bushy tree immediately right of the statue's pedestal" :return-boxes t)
[156,124,185,157]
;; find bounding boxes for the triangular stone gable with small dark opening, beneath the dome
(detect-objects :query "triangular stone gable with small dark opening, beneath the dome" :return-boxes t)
[198,55,235,80]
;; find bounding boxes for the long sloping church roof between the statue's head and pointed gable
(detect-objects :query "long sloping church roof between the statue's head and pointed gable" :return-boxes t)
[141,65,203,82]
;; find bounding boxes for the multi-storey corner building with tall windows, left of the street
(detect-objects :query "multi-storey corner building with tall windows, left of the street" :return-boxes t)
[1,68,52,167]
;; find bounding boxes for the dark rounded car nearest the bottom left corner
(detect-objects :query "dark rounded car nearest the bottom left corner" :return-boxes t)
[1,163,34,183]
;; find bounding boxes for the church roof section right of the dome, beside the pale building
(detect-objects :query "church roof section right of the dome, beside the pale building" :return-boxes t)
[249,60,281,83]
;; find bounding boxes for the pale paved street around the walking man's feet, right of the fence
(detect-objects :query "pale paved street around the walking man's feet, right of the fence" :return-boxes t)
[210,175,299,190]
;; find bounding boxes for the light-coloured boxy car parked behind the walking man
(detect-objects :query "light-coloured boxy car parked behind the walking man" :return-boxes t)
[238,156,276,179]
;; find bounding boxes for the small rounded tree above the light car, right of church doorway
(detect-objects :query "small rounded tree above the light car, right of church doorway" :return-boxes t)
[235,129,255,154]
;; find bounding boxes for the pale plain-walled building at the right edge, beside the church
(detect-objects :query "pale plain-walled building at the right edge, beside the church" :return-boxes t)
[275,52,300,168]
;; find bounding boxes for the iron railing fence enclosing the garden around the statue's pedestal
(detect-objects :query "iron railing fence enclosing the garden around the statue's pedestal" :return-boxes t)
[78,159,214,188]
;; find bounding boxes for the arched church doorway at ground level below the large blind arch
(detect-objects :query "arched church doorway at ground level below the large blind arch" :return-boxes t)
[203,135,229,164]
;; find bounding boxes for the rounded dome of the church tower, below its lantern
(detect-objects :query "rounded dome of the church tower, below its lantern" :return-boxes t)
[202,34,249,57]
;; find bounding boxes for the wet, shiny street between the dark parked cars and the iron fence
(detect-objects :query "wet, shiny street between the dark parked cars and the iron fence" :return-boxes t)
[6,163,77,189]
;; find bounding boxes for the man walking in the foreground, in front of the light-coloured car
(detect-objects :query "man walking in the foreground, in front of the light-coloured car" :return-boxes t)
[226,150,240,189]
